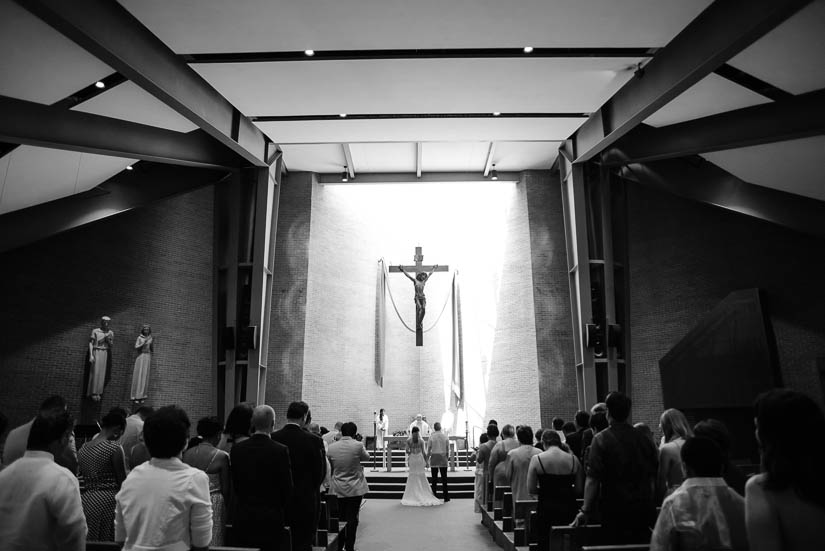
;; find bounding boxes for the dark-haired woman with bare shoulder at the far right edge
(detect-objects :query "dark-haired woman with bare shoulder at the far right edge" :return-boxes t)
[745,389,825,551]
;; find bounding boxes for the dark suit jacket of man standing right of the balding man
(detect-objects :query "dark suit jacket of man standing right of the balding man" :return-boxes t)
[272,425,326,502]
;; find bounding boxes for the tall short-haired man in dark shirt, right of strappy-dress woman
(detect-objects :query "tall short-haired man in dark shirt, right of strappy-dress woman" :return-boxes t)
[573,392,658,544]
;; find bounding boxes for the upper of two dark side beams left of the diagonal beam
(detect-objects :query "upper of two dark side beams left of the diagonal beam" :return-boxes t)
[0,96,243,168]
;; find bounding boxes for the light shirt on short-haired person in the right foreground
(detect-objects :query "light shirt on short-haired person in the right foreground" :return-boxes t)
[650,477,748,551]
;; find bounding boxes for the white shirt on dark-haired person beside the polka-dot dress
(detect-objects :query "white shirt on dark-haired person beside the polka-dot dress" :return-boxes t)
[115,457,212,551]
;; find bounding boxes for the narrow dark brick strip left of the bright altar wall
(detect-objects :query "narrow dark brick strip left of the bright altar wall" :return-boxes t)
[266,172,313,424]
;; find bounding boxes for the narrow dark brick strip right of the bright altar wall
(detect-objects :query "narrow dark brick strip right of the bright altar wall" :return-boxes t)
[524,171,578,427]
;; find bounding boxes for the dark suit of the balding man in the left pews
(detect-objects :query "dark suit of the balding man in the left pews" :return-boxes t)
[229,434,293,551]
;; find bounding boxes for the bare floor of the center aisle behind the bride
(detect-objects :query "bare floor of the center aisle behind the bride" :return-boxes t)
[355,499,501,551]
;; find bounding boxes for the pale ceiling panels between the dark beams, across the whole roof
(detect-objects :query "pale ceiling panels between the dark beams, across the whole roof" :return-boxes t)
[0,0,825,218]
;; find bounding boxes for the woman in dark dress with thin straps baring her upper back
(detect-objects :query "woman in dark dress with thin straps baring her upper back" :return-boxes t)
[514,430,584,551]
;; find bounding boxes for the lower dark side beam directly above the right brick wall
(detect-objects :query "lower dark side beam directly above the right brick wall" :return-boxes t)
[620,157,825,238]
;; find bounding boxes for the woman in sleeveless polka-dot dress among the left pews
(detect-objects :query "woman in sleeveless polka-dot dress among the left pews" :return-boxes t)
[77,413,126,541]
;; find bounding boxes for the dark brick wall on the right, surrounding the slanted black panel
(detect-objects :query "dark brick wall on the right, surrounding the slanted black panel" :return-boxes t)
[628,183,825,428]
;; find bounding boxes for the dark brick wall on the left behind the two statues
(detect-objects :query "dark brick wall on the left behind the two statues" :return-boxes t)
[0,187,215,438]
